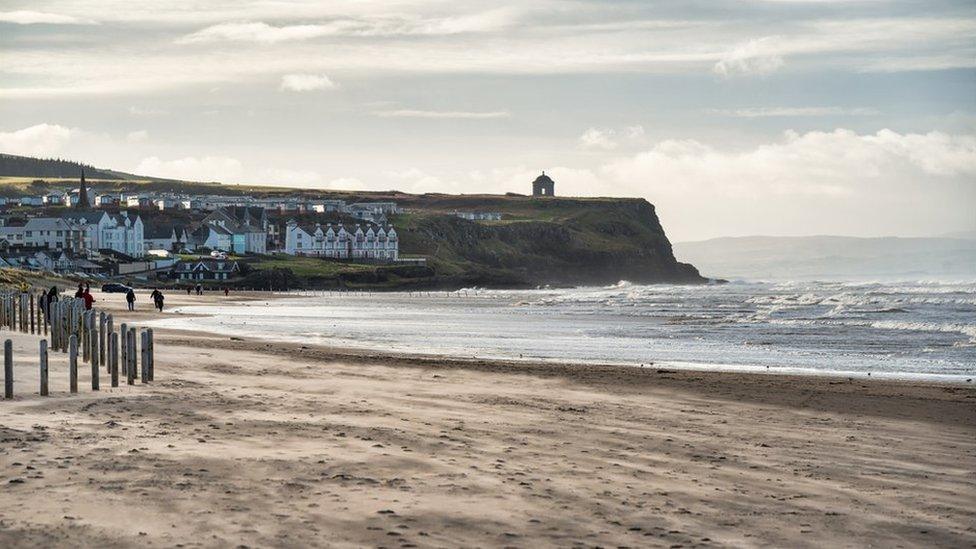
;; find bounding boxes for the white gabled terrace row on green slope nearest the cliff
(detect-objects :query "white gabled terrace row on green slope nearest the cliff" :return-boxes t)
[285,220,400,261]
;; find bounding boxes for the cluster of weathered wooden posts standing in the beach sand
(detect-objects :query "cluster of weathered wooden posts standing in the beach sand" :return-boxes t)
[0,291,154,399]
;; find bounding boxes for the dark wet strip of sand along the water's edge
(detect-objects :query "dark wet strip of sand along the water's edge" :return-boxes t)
[154,328,976,426]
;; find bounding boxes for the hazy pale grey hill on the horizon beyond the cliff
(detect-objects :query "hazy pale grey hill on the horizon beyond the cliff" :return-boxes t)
[674,236,976,280]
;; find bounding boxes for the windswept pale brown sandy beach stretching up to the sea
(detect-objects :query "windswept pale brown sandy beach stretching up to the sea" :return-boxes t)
[0,288,976,547]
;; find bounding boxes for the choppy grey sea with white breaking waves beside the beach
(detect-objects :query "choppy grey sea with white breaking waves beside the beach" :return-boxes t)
[147,280,976,383]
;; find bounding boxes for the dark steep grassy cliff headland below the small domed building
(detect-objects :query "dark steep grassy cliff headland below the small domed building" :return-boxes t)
[395,199,706,286]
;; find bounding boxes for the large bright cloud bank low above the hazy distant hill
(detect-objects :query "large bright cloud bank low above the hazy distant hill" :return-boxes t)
[599,129,976,238]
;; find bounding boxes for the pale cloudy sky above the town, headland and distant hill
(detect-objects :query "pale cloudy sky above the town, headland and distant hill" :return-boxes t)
[0,0,976,241]
